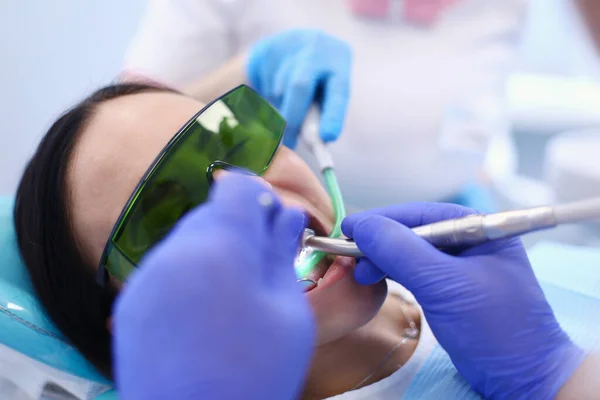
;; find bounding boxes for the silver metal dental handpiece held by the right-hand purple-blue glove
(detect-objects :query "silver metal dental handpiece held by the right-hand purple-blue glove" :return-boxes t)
[302,198,600,258]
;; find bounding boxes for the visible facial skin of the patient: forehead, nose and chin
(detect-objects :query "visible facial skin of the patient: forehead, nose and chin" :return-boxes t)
[68,92,386,344]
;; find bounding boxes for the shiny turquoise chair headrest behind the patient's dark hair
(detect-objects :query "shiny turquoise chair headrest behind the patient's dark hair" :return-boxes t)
[0,197,110,384]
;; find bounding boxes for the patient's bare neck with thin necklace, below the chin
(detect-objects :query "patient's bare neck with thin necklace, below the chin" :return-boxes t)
[303,294,421,400]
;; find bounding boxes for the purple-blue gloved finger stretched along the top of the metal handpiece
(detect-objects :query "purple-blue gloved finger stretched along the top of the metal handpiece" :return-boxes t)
[342,202,476,236]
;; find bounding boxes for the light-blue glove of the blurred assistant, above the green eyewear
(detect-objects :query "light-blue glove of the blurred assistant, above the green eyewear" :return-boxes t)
[247,29,352,148]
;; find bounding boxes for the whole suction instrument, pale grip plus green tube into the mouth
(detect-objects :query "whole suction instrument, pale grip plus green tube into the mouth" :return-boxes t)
[295,106,346,288]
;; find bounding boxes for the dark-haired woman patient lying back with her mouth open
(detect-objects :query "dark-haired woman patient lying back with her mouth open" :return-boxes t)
[15,84,434,399]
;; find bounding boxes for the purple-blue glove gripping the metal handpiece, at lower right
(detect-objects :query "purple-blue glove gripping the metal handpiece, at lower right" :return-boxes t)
[343,203,584,399]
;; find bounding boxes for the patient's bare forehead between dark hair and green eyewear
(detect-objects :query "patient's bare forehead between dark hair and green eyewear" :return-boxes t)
[67,92,202,264]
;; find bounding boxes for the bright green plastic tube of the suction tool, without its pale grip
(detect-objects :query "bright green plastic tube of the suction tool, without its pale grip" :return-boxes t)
[295,167,346,287]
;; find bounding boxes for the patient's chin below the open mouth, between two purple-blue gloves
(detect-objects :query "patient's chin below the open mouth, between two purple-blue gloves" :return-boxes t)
[310,274,387,346]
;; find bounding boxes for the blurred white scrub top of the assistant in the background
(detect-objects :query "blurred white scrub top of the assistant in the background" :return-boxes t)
[126,0,527,211]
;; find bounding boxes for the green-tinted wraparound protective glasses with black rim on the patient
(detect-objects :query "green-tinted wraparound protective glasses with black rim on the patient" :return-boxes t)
[97,85,286,285]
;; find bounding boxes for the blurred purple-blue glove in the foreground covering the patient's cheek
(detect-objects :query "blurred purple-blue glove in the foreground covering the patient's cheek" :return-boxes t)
[114,176,315,400]
